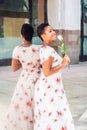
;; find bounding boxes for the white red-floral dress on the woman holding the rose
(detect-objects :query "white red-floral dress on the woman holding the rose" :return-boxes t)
[34,46,75,130]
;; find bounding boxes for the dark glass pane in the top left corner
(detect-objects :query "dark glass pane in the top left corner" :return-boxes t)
[0,0,29,12]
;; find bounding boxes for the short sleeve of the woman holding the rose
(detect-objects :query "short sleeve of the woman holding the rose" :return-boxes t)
[40,48,51,64]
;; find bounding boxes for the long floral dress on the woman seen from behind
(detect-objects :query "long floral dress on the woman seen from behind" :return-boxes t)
[3,45,40,130]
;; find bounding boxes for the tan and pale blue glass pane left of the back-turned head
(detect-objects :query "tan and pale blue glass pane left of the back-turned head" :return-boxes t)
[0,17,28,59]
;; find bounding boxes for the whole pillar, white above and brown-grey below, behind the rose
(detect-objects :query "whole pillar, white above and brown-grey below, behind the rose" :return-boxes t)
[48,0,80,64]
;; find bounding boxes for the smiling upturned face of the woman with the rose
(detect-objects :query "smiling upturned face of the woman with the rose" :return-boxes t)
[43,26,57,43]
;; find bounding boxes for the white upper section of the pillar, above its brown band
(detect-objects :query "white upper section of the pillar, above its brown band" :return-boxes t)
[47,0,80,30]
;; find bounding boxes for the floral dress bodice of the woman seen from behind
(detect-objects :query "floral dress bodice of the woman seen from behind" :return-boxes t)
[13,45,40,72]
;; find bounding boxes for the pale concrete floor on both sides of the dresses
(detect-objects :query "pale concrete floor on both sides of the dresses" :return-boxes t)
[0,62,87,130]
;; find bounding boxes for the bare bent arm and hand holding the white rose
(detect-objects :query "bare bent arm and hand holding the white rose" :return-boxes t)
[42,56,70,76]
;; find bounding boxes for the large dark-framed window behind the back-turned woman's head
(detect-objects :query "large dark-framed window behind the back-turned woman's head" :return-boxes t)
[0,0,47,60]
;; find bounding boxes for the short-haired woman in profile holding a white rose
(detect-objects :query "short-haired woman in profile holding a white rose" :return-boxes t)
[34,23,75,130]
